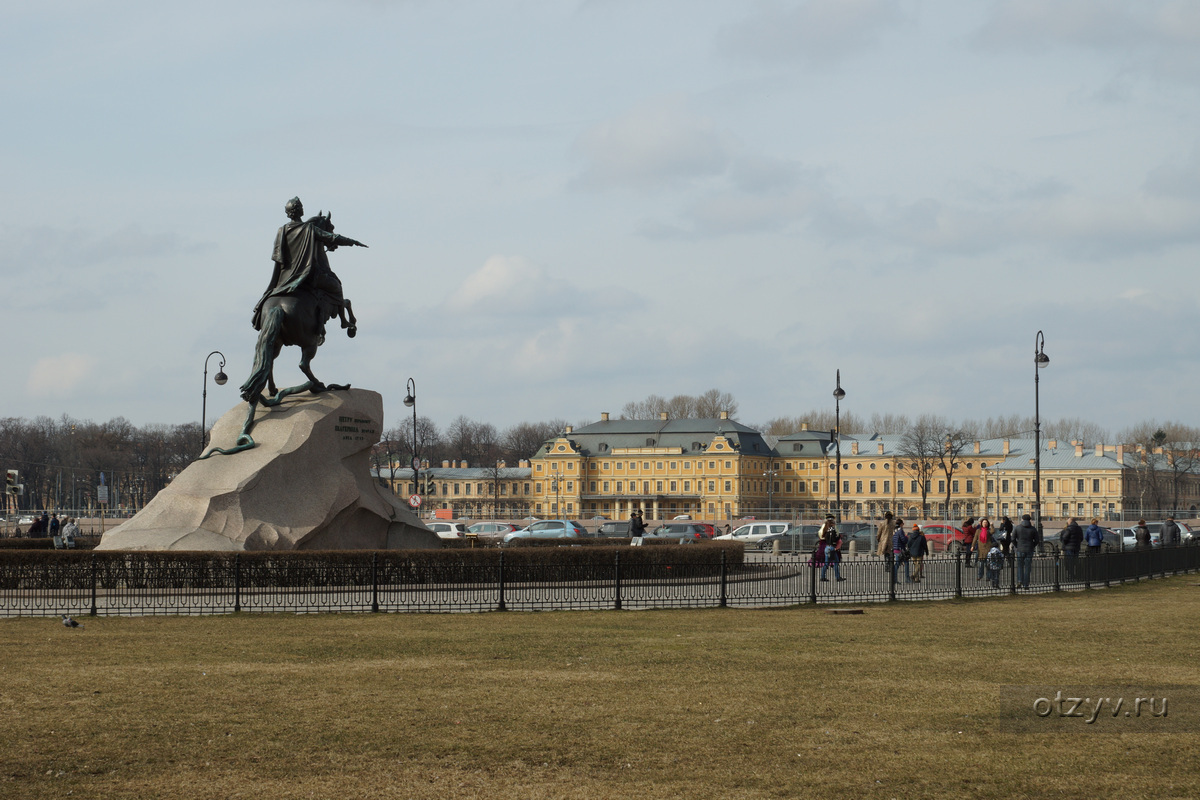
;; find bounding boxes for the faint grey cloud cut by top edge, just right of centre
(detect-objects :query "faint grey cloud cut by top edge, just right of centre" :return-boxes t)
[718,0,908,65]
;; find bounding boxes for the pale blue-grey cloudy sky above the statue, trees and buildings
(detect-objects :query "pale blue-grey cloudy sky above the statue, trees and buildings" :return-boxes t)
[7,0,1200,438]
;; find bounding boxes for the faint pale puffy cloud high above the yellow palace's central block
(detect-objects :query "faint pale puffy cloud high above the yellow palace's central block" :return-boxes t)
[575,96,734,188]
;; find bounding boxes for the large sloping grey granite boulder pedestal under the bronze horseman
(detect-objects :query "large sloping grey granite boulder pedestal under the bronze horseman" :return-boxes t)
[97,389,440,551]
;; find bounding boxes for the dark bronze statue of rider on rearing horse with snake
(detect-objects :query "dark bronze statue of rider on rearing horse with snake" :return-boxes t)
[200,197,366,458]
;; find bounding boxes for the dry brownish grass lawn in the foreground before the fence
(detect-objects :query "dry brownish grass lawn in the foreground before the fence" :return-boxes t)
[0,576,1200,800]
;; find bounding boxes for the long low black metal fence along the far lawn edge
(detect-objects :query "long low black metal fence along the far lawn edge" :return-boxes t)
[0,543,1200,616]
